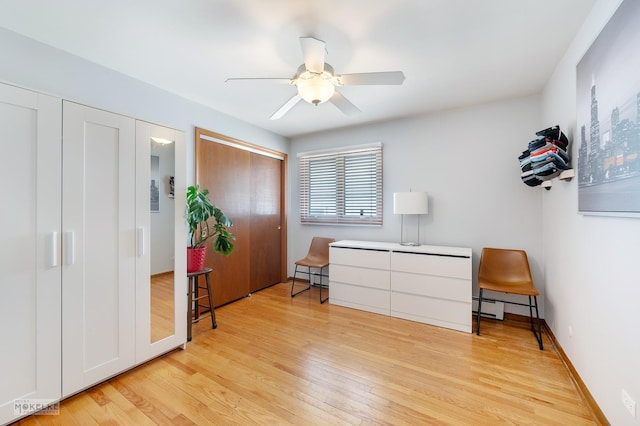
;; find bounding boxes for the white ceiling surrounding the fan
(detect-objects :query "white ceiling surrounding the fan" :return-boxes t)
[0,0,595,137]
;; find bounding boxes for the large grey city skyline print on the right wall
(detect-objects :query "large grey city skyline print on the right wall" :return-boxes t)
[574,0,640,215]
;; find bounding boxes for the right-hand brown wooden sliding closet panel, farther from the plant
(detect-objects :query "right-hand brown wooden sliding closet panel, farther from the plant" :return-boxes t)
[250,152,282,292]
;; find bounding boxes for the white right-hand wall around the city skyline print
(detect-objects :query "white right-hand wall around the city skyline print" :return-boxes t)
[542,0,640,425]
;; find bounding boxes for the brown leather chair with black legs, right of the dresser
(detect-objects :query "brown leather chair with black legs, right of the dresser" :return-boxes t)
[476,247,543,350]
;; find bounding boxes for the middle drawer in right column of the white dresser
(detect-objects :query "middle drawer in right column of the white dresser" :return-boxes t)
[391,271,471,303]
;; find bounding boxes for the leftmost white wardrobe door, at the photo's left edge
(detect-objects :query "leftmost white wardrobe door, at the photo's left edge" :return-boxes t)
[0,84,62,424]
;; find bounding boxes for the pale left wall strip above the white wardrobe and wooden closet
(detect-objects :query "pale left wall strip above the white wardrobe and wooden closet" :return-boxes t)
[0,28,289,181]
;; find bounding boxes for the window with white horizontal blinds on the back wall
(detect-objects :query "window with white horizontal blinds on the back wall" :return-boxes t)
[298,143,382,226]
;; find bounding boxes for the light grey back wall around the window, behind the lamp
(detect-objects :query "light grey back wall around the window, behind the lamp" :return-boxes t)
[288,97,544,316]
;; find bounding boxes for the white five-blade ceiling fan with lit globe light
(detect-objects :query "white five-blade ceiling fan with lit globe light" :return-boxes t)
[227,37,404,120]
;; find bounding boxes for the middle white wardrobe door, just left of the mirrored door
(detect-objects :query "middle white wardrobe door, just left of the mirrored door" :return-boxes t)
[62,101,136,397]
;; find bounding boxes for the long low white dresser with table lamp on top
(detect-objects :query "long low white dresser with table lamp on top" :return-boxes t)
[329,240,472,333]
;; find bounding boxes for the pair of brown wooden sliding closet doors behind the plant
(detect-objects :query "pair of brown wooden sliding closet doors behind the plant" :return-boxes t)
[196,129,286,306]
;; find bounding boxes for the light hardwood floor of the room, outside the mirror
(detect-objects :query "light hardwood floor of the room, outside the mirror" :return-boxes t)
[13,284,597,426]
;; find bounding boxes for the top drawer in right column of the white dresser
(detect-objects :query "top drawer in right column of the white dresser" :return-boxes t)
[391,252,471,280]
